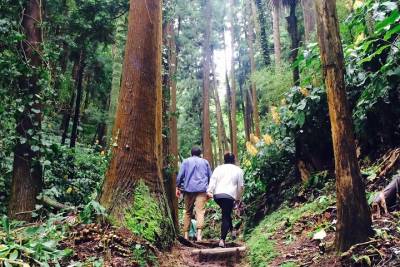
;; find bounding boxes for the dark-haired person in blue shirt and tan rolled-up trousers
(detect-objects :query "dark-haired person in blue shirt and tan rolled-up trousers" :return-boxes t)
[176,146,212,241]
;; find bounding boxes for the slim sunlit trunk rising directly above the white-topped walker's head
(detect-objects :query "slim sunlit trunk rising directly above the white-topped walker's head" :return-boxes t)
[228,0,239,159]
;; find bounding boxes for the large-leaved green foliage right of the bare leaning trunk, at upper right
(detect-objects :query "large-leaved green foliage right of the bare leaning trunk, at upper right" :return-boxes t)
[345,1,400,156]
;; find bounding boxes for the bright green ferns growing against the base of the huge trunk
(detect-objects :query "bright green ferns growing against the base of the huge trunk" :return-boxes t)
[125,182,167,246]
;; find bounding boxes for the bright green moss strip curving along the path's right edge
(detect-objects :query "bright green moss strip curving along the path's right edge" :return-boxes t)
[246,196,333,267]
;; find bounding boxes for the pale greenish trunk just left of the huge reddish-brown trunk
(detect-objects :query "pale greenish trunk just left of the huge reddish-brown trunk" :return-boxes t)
[107,16,126,141]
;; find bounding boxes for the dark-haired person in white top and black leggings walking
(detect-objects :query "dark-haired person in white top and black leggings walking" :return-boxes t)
[207,152,244,247]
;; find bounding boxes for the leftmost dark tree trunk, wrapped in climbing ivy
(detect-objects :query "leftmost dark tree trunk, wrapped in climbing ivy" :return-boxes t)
[8,0,43,220]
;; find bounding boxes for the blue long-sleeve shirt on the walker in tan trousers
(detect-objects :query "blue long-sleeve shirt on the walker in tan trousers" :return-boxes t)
[176,156,212,193]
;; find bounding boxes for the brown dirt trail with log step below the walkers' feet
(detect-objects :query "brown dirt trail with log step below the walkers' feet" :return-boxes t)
[160,241,249,267]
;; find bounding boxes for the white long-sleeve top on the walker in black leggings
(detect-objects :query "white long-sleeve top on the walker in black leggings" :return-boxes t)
[207,164,244,200]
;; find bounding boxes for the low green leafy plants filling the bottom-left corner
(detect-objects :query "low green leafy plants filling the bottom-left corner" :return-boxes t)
[0,214,73,266]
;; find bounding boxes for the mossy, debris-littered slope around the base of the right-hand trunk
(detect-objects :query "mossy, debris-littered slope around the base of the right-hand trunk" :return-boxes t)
[246,149,400,267]
